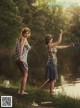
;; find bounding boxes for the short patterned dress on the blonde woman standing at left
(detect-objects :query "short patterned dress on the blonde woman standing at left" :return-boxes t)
[15,39,31,71]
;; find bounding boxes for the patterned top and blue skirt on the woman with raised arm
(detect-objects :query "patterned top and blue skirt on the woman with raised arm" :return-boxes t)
[46,45,58,80]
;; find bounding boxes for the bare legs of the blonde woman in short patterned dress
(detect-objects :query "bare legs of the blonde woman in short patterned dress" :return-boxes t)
[18,71,28,95]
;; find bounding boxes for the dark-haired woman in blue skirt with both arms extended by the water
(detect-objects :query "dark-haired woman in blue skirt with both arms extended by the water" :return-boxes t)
[45,30,72,95]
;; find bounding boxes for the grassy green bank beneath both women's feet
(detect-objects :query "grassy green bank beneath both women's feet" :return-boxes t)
[0,78,80,108]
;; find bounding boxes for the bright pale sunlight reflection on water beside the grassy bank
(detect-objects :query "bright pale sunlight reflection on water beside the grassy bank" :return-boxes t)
[55,75,80,98]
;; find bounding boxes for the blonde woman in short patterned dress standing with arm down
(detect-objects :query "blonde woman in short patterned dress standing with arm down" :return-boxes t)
[16,27,31,95]
